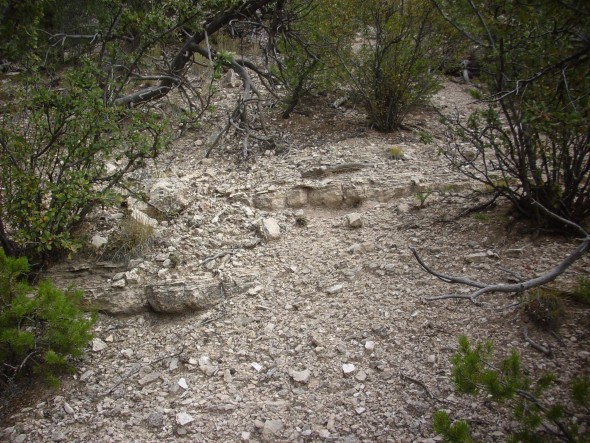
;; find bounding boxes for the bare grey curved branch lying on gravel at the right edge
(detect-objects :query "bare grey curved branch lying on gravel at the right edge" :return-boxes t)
[410,202,590,303]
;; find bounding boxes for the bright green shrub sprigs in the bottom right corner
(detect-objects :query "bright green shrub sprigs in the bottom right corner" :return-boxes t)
[433,336,590,442]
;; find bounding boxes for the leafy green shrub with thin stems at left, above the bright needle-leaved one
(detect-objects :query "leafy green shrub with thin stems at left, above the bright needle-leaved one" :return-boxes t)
[0,63,170,264]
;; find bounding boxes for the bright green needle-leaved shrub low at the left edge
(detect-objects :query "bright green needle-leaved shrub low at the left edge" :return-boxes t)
[0,249,95,390]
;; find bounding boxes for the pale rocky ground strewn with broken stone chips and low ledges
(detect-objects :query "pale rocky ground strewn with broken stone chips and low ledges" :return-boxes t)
[0,83,590,442]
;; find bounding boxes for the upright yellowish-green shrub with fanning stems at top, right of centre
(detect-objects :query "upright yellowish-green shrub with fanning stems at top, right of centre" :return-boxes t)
[340,0,441,131]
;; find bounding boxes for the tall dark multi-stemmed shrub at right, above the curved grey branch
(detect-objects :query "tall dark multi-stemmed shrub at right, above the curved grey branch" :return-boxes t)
[440,0,590,225]
